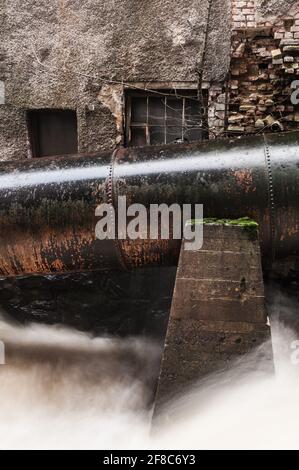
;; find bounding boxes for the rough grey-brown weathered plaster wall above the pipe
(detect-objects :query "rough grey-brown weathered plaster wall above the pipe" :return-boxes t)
[0,0,230,160]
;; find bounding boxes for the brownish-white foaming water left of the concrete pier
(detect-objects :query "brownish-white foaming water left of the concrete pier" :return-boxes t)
[0,322,160,449]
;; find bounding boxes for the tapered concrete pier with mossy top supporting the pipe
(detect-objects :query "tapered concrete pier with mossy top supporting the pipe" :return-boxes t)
[155,223,272,415]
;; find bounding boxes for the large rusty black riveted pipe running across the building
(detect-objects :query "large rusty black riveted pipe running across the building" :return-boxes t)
[0,132,299,276]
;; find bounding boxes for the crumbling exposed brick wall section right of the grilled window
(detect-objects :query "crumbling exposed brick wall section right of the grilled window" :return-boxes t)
[225,0,299,135]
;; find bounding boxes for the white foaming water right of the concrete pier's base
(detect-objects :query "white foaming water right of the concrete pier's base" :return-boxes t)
[155,325,299,449]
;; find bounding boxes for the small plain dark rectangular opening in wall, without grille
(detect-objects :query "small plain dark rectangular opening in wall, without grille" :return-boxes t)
[27,109,78,157]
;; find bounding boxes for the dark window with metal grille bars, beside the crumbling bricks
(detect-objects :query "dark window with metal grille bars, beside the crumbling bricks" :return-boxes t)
[126,90,207,147]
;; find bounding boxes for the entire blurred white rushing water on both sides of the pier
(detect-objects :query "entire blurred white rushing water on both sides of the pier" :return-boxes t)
[0,288,299,449]
